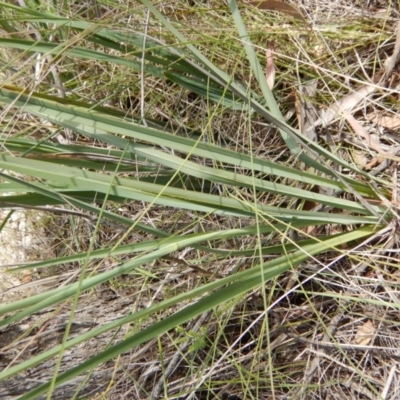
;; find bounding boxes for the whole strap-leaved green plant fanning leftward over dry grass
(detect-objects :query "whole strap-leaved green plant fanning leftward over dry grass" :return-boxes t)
[0,0,392,399]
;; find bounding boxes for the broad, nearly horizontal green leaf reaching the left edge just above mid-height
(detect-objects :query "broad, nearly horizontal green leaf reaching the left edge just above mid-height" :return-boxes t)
[0,154,381,225]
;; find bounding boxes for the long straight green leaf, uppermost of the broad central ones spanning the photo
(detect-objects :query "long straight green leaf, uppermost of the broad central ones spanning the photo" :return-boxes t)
[0,88,377,198]
